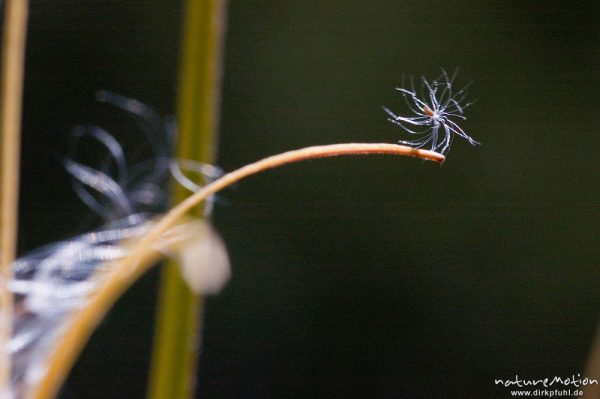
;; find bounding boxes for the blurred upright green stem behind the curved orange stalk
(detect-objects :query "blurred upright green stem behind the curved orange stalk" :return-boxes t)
[149,0,226,399]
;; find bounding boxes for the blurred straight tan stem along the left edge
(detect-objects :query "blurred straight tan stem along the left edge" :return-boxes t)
[0,0,28,395]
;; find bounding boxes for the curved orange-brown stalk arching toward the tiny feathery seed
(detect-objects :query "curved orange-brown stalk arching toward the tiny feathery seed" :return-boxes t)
[31,143,445,399]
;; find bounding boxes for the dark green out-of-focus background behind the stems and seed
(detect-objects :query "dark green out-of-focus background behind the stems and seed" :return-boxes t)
[10,0,600,398]
